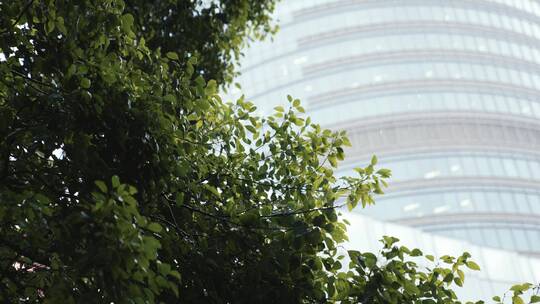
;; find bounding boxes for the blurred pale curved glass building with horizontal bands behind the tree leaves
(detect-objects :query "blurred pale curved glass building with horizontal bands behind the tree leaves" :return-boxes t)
[227,0,540,300]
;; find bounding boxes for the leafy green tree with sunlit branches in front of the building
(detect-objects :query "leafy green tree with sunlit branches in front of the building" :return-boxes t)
[0,0,540,303]
